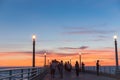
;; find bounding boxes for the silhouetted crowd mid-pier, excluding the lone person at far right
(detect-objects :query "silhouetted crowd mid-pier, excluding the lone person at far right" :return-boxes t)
[50,60,84,78]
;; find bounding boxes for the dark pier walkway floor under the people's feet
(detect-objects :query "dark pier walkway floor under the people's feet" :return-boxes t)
[43,71,116,80]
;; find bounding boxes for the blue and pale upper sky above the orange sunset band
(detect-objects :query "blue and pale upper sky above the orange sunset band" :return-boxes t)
[0,0,120,52]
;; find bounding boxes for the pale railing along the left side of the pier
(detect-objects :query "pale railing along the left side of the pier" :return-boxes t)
[0,67,46,80]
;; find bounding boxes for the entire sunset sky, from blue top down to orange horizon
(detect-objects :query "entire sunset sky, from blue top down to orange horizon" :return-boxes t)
[0,0,120,66]
